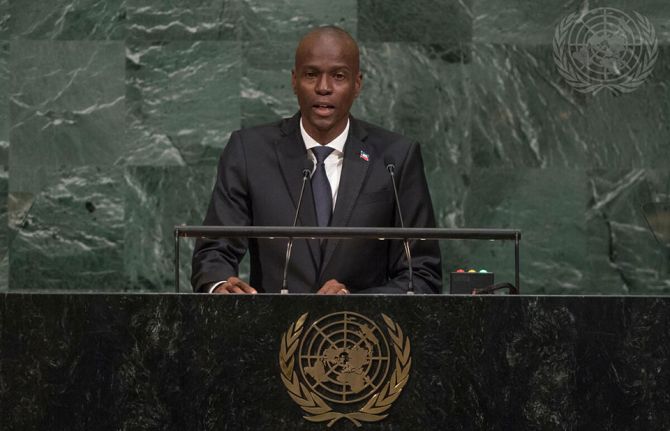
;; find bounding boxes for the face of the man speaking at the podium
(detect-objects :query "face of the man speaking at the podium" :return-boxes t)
[291,33,362,144]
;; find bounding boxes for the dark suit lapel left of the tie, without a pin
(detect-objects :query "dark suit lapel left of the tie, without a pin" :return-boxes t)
[275,114,321,268]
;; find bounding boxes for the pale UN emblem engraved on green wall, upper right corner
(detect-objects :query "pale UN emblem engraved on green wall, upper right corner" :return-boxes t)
[553,7,658,94]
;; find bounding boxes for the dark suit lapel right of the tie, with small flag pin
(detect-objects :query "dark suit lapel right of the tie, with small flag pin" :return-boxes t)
[321,118,369,273]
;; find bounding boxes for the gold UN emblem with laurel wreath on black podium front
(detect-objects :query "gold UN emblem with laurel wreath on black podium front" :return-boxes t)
[279,311,412,427]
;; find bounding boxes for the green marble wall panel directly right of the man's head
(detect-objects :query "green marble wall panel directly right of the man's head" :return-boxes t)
[352,42,471,173]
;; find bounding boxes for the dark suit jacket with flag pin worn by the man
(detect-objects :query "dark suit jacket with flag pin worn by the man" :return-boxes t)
[191,114,442,293]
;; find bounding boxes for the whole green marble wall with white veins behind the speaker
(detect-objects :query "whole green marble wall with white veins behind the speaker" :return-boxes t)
[0,0,670,294]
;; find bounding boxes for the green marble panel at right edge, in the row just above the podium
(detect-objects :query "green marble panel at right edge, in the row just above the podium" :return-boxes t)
[586,169,670,294]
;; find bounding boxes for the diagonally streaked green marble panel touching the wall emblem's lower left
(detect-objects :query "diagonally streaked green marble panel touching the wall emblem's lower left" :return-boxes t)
[469,44,589,168]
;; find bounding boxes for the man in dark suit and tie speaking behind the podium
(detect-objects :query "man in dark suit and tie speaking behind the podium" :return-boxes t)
[191,27,441,294]
